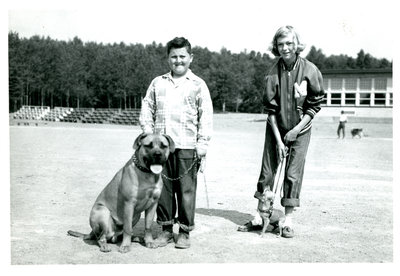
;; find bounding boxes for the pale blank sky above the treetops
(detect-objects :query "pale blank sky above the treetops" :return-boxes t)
[7,0,396,60]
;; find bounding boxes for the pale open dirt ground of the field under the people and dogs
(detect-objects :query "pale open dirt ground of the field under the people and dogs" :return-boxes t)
[5,114,393,265]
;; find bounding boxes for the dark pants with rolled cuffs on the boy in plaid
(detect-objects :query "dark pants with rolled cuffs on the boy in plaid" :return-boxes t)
[157,149,198,232]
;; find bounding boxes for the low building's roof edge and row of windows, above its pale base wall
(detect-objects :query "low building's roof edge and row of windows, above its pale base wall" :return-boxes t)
[321,69,393,108]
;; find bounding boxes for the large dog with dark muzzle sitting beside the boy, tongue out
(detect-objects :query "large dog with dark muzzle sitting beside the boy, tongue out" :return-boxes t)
[68,134,175,253]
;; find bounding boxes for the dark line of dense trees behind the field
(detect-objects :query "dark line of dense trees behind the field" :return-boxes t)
[8,32,392,113]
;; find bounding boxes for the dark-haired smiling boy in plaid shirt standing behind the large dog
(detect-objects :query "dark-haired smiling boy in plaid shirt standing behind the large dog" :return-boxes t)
[140,37,213,249]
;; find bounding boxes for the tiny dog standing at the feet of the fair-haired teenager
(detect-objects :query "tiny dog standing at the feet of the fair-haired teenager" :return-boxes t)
[254,188,286,237]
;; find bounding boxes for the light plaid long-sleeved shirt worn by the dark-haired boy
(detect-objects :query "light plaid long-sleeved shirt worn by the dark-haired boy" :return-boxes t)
[139,70,213,149]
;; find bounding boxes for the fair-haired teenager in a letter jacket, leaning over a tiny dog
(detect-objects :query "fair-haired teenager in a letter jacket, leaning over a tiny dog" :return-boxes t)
[238,26,325,238]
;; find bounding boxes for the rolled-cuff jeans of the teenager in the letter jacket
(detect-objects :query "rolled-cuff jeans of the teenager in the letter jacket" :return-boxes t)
[257,124,311,207]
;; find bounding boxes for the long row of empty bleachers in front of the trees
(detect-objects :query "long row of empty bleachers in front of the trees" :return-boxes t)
[12,106,140,125]
